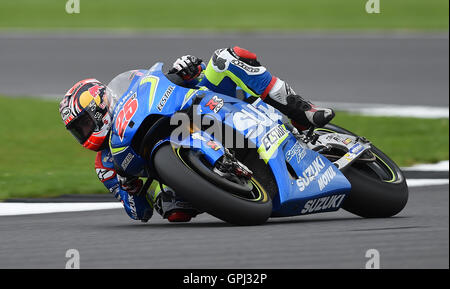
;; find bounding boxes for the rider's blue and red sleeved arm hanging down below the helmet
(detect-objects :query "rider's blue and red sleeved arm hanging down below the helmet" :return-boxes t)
[95,149,153,221]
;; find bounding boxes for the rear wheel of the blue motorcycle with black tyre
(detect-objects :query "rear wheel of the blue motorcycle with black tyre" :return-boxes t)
[317,124,408,218]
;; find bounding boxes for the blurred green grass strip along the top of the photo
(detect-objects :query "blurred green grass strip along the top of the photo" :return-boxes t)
[0,0,449,31]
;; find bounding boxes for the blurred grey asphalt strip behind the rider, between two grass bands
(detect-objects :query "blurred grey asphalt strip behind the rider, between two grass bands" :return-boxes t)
[0,32,449,107]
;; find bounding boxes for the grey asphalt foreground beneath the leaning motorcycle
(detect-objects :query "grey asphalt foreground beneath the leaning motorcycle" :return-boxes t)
[0,185,449,269]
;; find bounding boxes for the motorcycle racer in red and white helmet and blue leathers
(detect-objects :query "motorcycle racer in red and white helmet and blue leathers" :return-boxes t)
[59,46,334,222]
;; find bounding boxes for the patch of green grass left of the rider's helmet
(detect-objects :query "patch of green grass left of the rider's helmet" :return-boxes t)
[0,97,105,199]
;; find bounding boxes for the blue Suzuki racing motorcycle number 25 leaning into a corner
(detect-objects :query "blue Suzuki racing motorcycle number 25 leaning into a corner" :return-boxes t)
[108,63,408,225]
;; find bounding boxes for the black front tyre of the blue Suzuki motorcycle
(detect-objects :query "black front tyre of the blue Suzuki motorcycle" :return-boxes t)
[153,144,272,225]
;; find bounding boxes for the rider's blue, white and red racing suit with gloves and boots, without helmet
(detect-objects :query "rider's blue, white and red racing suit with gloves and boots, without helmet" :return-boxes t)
[95,47,334,222]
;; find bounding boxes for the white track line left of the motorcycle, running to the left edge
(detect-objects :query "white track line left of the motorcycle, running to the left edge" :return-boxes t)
[0,202,123,216]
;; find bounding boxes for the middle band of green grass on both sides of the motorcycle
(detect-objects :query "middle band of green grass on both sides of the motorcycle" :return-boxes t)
[0,97,449,199]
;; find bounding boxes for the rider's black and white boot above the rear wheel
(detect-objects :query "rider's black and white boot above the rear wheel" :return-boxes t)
[263,78,334,131]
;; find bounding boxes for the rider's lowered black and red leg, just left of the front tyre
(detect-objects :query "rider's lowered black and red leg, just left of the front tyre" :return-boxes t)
[154,186,201,222]
